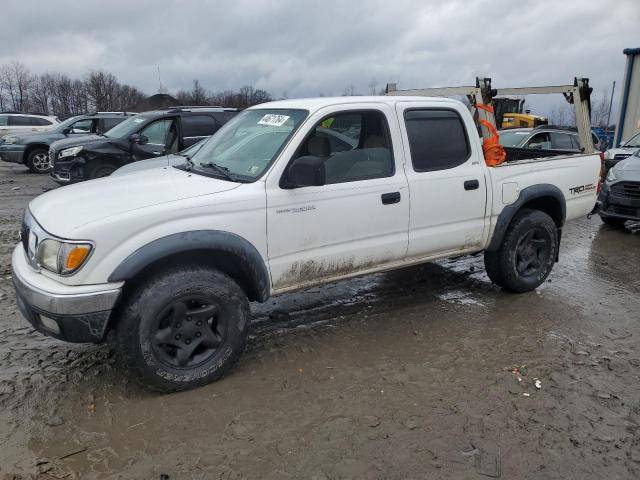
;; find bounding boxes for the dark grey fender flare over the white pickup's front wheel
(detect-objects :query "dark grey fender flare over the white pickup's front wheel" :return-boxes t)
[109,230,271,302]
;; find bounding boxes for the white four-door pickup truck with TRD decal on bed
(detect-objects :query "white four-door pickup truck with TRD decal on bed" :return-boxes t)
[12,97,601,391]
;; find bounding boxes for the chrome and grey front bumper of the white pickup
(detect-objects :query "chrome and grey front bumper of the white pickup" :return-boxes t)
[11,244,122,343]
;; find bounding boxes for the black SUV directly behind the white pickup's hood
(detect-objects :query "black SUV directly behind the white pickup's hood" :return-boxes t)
[49,107,238,184]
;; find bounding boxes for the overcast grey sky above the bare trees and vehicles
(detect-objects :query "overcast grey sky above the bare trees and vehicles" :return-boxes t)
[0,0,640,113]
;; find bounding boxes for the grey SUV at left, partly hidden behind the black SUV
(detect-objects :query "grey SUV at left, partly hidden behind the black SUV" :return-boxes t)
[0,112,135,173]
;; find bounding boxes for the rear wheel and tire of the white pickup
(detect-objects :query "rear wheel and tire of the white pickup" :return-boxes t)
[484,209,559,293]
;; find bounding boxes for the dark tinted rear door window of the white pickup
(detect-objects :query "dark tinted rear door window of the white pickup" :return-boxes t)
[404,109,471,172]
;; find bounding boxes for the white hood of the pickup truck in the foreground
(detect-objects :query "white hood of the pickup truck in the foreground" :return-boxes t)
[29,164,240,238]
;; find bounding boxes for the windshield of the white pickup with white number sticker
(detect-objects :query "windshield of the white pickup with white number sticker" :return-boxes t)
[191,109,308,181]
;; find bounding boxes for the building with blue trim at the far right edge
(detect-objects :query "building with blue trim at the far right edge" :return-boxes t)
[615,48,640,146]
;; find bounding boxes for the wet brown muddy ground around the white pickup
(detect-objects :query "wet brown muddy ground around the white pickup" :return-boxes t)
[0,164,640,480]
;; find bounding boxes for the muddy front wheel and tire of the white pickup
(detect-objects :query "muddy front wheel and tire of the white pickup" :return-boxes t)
[115,267,249,392]
